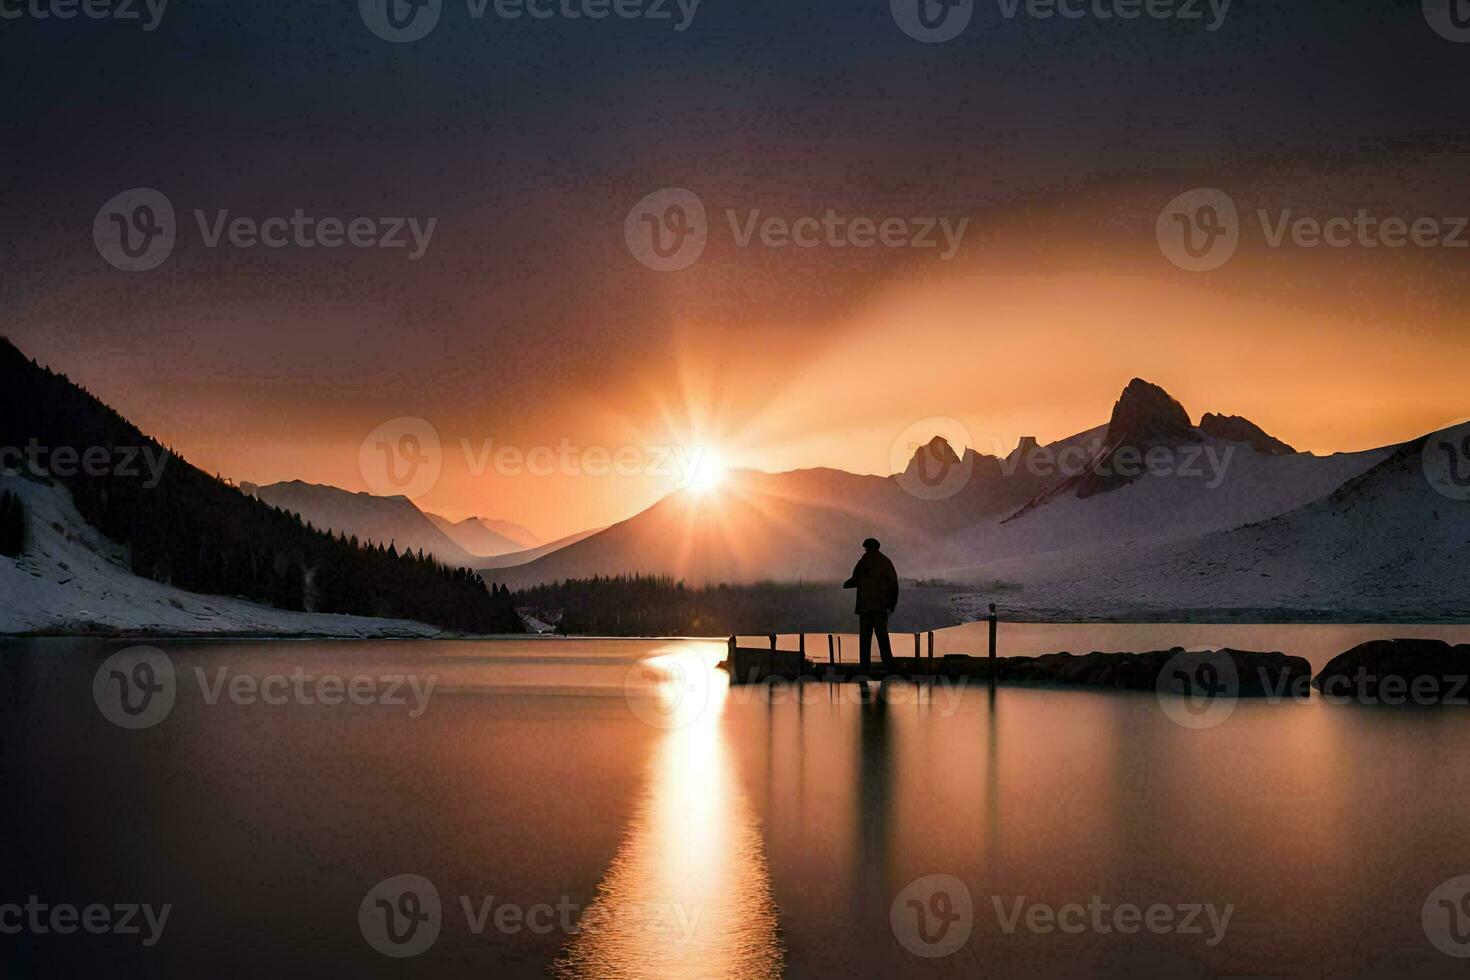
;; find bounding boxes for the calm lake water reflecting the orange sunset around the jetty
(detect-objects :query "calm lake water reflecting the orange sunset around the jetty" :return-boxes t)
[0,624,1470,977]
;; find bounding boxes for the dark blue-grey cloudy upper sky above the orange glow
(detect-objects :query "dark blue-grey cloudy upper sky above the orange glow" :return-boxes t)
[0,0,1470,531]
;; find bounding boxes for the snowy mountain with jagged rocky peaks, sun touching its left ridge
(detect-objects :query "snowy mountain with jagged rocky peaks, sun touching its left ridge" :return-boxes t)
[504,379,1428,605]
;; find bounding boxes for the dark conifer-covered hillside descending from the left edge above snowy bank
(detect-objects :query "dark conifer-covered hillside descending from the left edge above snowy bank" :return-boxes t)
[0,339,522,633]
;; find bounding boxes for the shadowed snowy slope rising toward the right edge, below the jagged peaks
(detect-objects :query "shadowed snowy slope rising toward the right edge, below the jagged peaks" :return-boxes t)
[956,436,1470,621]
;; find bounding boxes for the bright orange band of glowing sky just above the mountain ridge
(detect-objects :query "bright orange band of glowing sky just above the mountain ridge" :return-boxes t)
[132,268,1467,536]
